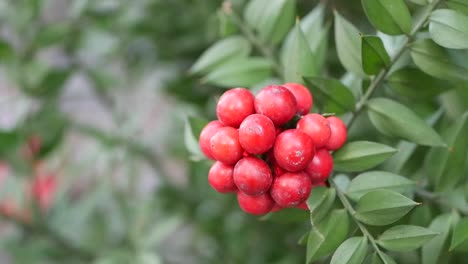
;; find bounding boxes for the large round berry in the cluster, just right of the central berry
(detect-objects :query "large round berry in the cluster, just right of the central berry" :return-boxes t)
[273,129,315,171]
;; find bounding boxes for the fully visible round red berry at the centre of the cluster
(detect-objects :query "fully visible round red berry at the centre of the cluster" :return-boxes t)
[239,114,276,154]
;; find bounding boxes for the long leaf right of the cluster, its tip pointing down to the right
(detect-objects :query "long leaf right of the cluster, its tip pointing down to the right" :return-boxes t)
[367,98,445,146]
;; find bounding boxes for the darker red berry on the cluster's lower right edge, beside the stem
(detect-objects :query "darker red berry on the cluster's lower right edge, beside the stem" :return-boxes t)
[304,149,333,184]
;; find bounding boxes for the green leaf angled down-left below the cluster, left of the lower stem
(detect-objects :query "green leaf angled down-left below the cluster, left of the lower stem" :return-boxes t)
[306,209,349,263]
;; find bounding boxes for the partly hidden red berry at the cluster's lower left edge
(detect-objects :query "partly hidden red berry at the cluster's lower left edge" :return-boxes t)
[208,161,237,193]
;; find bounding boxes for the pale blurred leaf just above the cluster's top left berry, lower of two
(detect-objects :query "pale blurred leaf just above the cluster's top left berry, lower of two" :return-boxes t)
[202,57,271,88]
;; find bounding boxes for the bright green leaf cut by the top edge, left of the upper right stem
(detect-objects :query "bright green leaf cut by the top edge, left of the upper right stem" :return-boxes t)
[362,0,412,35]
